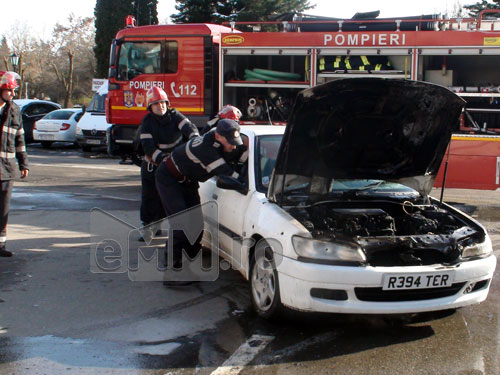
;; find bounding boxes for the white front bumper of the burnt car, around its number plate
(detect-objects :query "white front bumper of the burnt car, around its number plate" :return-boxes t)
[278,255,497,314]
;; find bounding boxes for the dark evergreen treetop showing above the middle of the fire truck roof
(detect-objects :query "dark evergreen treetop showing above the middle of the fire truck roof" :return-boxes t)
[170,0,313,23]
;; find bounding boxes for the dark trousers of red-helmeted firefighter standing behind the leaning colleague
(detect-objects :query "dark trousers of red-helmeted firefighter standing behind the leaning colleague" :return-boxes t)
[140,161,165,225]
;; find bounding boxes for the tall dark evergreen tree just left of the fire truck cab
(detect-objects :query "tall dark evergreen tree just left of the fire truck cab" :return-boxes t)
[94,0,134,78]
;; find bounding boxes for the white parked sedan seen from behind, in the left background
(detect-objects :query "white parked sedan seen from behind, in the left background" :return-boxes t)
[33,108,83,148]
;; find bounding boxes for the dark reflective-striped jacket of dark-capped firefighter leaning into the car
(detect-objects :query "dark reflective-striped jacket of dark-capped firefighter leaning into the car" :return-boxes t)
[172,129,248,182]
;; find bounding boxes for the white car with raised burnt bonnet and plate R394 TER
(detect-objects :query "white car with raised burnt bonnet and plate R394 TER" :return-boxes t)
[200,78,496,318]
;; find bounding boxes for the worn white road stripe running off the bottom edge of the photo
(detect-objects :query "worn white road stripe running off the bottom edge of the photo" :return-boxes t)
[211,335,274,375]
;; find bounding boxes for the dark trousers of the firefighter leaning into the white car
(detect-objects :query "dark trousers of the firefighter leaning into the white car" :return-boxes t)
[156,163,203,268]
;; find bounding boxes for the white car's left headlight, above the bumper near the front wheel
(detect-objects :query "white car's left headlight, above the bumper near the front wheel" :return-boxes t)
[292,236,366,263]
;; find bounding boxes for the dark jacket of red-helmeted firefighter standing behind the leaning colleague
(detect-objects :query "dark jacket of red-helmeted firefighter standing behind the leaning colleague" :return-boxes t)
[139,108,198,165]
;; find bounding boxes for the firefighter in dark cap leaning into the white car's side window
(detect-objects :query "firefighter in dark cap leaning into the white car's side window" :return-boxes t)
[156,119,248,285]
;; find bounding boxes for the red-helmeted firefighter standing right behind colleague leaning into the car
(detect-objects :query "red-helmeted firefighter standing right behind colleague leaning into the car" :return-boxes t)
[139,86,199,241]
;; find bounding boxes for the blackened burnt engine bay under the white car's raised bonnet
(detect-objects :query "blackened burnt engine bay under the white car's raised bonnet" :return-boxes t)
[288,201,485,267]
